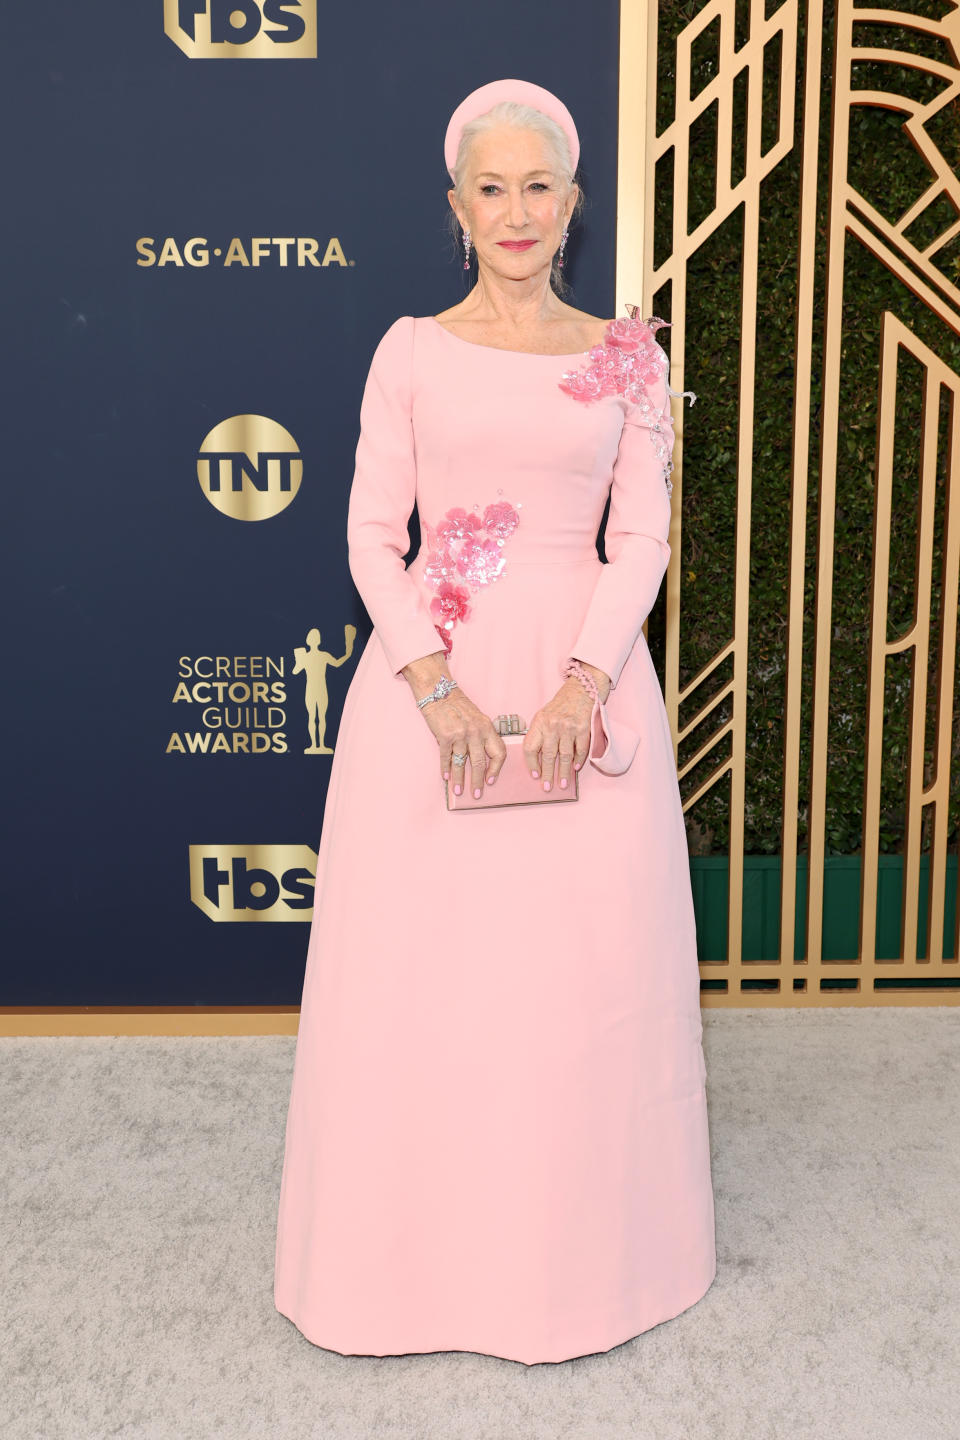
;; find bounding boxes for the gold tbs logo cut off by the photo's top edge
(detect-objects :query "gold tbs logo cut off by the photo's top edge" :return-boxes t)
[163,0,317,60]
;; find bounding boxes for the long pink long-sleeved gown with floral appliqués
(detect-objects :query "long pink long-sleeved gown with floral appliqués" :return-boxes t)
[275,315,715,1365]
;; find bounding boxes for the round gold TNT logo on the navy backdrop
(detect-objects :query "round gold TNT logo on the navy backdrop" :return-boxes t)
[197,415,304,520]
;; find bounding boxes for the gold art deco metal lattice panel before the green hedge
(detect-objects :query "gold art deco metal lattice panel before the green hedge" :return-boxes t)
[616,0,960,1005]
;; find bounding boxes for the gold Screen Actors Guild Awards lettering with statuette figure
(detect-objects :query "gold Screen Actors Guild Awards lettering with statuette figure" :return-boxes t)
[166,625,357,755]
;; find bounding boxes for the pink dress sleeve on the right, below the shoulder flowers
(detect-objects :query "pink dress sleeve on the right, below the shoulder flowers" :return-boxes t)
[570,346,679,685]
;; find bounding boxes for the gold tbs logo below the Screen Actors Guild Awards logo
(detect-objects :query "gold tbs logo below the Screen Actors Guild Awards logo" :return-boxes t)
[190,845,317,922]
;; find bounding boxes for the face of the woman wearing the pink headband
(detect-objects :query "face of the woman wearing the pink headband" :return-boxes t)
[448,125,579,279]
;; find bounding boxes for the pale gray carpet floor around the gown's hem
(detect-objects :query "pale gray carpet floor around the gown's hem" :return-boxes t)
[0,1007,960,1440]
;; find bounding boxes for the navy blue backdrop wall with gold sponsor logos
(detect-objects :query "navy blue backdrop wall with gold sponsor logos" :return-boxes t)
[0,0,619,1005]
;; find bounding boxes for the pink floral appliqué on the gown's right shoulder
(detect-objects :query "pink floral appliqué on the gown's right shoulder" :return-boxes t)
[558,305,697,495]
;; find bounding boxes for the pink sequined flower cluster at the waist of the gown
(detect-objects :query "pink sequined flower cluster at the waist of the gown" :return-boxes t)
[423,491,522,655]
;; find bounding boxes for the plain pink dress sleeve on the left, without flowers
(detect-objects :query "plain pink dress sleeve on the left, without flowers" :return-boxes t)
[347,315,443,674]
